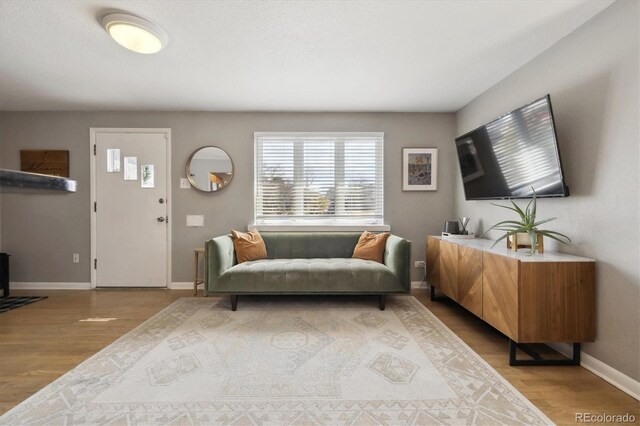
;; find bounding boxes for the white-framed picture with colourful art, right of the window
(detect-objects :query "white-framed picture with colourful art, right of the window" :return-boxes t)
[402,148,438,191]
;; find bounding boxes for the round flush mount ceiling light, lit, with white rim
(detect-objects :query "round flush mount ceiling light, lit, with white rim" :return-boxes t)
[102,13,169,54]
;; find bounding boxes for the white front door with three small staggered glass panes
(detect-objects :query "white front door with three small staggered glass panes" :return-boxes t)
[92,129,170,287]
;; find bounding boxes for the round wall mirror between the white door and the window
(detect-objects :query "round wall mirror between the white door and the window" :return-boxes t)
[187,146,233,192]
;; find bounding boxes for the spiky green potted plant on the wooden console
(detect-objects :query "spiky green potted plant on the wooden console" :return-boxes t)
[481,188,571,255]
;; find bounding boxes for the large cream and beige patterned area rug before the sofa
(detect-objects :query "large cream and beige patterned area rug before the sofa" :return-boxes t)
[0,296,551,425]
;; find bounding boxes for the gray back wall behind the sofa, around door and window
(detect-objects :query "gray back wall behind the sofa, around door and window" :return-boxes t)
[0,112,457,282]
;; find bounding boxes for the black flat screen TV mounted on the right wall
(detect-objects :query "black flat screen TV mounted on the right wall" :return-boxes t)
[456,95,569,200]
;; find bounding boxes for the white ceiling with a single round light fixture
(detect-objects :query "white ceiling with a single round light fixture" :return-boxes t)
[0,0,613,112]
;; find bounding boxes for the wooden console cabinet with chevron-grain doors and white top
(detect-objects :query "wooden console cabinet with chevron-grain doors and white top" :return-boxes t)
[426,237,595,365]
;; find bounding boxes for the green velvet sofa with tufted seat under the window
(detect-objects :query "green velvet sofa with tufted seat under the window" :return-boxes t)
[204,232,411,311]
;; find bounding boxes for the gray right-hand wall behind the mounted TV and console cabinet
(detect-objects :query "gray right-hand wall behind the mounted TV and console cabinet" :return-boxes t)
[455,0,640,380]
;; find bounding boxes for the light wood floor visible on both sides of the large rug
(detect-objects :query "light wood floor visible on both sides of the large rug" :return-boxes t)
[0,289,640,424]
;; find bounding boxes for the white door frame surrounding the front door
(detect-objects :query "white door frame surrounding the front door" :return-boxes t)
[89,127,173,289]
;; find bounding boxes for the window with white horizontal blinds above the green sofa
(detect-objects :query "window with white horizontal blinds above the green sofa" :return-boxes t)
[254,133,384,226]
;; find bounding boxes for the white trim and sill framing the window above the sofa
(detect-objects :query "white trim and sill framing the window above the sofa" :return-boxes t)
[254,132,384,232]
